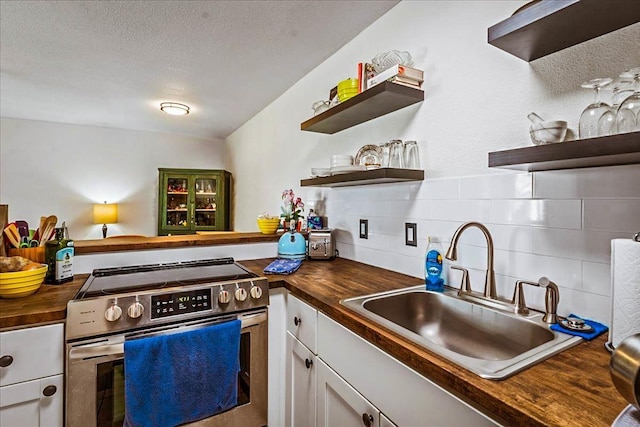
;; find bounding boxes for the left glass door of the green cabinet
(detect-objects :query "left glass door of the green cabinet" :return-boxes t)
[158,172,193,234]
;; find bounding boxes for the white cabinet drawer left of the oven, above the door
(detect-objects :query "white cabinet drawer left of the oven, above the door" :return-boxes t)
[0,323,64,386]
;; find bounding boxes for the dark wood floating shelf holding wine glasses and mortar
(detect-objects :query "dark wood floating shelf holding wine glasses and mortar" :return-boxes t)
[489,132,640,172]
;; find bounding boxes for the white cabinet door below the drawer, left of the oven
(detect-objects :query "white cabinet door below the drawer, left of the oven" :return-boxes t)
[0,375,64,427]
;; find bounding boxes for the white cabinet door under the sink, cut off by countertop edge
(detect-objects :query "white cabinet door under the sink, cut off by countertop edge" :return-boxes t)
[318,359,380,427]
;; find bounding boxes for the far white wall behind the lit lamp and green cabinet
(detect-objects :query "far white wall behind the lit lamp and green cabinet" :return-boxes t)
[0,118,226,239]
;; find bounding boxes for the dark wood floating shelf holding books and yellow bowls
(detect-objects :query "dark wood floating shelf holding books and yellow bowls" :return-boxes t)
[300,82,424,134]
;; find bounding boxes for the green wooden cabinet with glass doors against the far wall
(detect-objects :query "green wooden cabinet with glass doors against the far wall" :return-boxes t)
[158,168,231,236]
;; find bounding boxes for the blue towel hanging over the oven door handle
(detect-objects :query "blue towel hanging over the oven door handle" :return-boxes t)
[124,320,241,427]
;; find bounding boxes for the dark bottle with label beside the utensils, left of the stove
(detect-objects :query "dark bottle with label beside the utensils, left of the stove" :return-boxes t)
[44,224,74,285]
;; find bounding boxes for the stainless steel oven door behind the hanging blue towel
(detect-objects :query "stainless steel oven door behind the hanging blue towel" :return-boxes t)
[66,310,267,427]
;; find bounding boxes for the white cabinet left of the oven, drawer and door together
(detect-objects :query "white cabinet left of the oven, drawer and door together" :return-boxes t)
[0,324,64,427]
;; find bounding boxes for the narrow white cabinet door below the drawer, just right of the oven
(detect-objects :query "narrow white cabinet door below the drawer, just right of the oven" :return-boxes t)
[285,332,317,427]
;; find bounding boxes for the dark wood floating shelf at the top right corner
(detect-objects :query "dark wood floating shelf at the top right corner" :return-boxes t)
[488,0,640,61]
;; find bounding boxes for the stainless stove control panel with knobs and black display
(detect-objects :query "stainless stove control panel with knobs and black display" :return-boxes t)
[66,277,269,340]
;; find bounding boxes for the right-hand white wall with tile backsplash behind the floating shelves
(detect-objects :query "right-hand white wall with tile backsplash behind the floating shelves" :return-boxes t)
[226,1,640,321]
